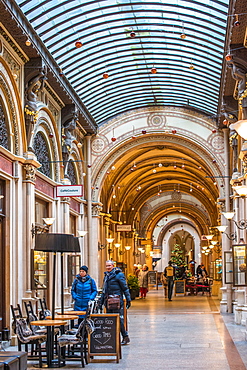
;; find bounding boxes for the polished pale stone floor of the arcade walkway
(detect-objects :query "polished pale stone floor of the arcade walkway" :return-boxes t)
[8,288,247,370]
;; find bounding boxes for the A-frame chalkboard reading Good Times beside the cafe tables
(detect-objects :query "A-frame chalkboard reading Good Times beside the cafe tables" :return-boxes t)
[88,314,121,362]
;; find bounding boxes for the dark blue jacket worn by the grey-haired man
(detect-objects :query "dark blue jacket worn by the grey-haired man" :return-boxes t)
[100,267,131,306]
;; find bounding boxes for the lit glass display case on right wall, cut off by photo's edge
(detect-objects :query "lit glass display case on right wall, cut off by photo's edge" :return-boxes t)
[232,244,247,286]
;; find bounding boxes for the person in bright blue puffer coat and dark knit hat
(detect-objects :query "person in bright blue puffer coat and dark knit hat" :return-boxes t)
[71,266,97,324]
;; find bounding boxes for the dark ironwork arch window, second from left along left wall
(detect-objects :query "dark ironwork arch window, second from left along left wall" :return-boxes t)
[34,132,51,178]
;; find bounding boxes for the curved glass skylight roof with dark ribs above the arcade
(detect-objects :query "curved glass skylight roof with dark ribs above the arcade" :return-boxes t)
[16,0,228,125]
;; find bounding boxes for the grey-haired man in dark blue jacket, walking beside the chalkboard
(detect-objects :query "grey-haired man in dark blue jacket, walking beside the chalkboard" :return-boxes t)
[100,261,131,345]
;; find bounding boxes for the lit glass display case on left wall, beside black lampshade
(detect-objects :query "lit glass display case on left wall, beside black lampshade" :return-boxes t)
[32,250,49,290]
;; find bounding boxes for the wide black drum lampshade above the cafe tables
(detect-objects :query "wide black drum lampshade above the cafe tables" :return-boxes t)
[34,233,80,253]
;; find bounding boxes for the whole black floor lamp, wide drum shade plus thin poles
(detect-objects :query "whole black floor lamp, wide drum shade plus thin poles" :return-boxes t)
[34,233,80,319]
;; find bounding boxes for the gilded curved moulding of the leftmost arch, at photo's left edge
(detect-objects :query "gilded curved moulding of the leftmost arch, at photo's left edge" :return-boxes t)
[0,71,20,155]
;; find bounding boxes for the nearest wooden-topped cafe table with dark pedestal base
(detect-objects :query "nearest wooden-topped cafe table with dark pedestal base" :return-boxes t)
[30,320,67,367]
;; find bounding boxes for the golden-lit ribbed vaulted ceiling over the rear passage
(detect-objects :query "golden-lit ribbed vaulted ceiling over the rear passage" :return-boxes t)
[100,135,224,236]
